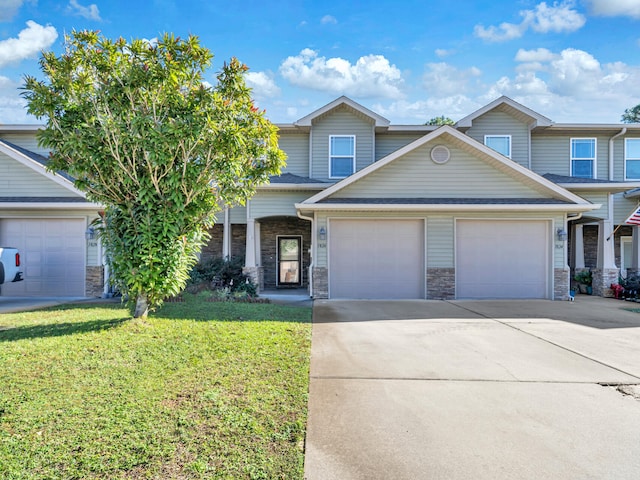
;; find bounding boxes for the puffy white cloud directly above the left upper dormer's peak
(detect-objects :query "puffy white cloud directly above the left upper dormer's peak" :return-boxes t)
[280,48,403,98]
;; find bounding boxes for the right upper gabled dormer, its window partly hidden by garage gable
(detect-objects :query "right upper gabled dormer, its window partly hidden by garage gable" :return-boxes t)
[456,96,553,168]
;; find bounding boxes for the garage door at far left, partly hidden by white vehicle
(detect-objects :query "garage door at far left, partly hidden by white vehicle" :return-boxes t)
[0,218,86,296]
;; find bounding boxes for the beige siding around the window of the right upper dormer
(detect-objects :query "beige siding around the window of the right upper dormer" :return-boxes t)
[467,112,529,167]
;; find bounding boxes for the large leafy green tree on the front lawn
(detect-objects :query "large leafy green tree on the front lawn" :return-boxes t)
[23,31,284,317]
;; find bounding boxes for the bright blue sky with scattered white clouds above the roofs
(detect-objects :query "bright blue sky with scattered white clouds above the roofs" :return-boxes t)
[0,0,640,124]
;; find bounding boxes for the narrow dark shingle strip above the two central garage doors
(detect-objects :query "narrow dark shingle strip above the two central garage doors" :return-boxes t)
[318,198,572,205]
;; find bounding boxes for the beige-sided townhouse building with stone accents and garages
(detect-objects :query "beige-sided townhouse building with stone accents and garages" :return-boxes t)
[0,97,640,300]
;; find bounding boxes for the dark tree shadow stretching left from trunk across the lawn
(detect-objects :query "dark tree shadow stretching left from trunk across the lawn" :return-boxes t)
[0,318,130,342]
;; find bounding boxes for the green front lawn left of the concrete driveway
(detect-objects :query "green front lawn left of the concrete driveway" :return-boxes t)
[0,297,311,480]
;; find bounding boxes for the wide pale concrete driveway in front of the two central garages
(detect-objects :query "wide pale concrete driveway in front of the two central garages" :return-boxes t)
[305,296,640,480]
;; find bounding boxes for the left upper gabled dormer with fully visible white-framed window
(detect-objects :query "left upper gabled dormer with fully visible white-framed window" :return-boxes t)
[294,96,389,181]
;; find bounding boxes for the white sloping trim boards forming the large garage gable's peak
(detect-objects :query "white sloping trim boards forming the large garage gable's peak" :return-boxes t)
[305,125,585,204]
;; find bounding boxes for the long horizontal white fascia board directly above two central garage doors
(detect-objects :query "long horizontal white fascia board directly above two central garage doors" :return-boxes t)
[294,203,602,212]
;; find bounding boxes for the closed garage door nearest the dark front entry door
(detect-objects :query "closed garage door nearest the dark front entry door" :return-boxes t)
[329,220,425,299]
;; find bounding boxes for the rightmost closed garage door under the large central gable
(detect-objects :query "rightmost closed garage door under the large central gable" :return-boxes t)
[456,220,552,298]
